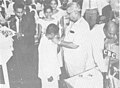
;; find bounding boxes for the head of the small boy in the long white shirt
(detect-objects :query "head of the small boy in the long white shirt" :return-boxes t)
[46,23,59,39]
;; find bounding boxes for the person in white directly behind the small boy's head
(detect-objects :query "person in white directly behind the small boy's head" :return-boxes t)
[36,6,58,43]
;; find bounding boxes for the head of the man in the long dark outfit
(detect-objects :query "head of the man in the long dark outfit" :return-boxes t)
[13,3,25,18]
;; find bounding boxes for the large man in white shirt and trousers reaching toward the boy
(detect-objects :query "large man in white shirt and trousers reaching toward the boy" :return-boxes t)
[54,2,102,88]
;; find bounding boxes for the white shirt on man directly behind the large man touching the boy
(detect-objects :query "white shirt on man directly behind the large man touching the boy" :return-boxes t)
[91,23,107,72]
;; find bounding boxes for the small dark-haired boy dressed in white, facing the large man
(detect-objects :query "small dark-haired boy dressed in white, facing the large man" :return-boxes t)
[38,24,61,88]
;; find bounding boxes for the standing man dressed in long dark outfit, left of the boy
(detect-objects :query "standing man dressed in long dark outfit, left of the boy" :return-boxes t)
[8,3,40,88]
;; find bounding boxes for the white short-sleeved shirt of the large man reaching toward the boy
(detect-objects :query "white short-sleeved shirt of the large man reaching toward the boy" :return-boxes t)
[64,17,94,76]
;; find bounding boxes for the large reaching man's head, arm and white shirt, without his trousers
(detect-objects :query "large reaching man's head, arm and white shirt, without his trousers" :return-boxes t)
[55,3,90,76]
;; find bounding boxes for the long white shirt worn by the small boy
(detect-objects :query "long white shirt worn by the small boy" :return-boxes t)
[38,35,61,78]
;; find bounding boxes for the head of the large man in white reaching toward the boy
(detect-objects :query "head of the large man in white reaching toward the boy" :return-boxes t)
[67,2,81,22]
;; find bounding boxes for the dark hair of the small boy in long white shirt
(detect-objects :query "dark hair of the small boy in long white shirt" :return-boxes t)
[46,23,59,35]
